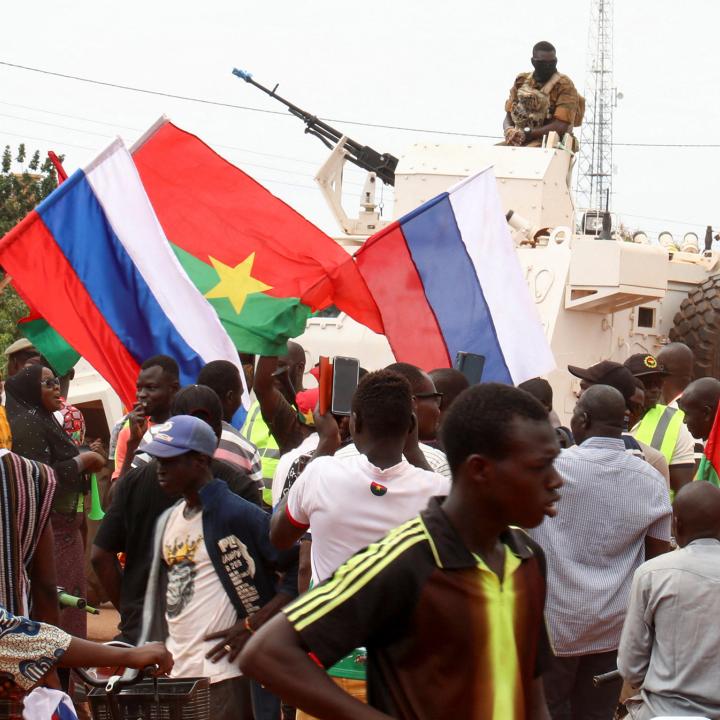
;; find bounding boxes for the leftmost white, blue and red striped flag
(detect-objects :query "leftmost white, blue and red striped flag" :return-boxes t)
[0,139,238,407]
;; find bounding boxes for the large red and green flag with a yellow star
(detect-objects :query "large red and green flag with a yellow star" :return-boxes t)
[133,120,382,355]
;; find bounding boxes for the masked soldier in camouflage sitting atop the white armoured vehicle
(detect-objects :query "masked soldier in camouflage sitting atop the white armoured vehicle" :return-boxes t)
[503,41,585,147]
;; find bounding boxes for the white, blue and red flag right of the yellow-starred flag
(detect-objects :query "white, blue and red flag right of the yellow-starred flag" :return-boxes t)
[354,168,555,385]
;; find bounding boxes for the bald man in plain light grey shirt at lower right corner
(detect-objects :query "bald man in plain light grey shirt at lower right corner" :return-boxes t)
[618,482,720,720]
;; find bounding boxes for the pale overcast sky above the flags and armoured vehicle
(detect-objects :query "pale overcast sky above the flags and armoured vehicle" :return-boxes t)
[0,0,720,243]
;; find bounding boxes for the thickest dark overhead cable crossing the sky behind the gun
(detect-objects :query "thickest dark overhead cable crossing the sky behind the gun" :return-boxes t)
[0,60,720,148]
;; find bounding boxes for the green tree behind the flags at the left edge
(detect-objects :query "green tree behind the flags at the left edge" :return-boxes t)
[0,143,63,358]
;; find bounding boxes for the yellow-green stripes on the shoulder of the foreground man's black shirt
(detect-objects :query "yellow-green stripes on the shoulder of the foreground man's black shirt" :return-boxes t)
[283,518,428,632]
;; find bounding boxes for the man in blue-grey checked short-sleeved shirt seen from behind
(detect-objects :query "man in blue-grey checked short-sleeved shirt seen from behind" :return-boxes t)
[530,385,671,720]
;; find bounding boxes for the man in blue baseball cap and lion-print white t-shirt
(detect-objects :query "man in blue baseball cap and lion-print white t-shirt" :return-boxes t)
[141,415,297,720]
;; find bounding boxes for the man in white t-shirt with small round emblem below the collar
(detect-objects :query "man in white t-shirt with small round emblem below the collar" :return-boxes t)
[270,370,450,718]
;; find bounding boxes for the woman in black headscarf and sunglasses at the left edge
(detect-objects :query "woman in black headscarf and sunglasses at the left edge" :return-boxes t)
[5,365,105,637]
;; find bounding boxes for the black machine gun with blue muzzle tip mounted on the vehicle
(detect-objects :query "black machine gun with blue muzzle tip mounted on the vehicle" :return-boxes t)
[233,68,398,185]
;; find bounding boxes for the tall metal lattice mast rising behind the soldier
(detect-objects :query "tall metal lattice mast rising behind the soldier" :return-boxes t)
[575,0,618,210]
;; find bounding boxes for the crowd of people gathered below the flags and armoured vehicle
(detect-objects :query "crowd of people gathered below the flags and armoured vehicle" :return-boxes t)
[0,334,720,720]
